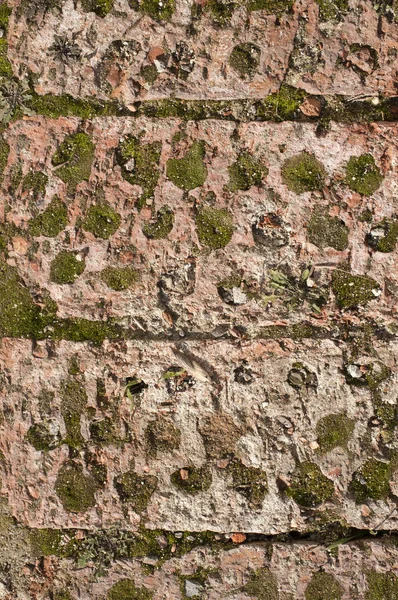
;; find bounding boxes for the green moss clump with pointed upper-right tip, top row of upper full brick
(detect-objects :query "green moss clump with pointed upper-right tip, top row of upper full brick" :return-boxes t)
[166,140,207,191]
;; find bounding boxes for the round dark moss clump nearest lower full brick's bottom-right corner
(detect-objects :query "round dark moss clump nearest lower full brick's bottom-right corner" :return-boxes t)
[349,458,391,503]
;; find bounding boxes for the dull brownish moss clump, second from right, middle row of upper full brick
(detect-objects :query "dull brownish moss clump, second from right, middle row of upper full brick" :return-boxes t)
[307,208,349,251]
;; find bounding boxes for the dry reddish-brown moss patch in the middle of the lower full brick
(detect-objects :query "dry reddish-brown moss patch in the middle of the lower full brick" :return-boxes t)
[199,414,242,458]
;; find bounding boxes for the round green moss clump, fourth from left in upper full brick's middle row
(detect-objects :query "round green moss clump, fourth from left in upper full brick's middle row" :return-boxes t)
[196,206,234,250]
